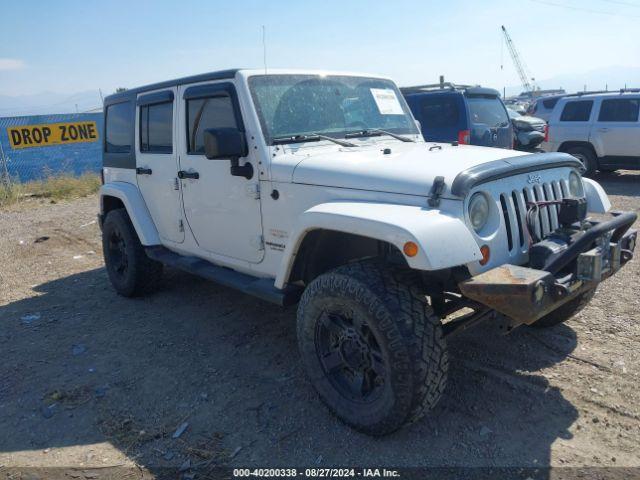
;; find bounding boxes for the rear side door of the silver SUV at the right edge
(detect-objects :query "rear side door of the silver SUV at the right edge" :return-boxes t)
[591,96,640,166]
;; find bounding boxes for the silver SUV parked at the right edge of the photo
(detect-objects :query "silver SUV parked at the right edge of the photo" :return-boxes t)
[542,89,640,175]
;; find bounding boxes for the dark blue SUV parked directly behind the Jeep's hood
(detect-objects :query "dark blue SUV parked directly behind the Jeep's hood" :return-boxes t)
[401,83,513,148]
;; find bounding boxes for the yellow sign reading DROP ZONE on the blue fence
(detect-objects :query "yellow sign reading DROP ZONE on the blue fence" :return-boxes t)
[7,122,98,149]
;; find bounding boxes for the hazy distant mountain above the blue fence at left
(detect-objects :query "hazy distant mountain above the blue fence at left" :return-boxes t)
[0,90,102,117]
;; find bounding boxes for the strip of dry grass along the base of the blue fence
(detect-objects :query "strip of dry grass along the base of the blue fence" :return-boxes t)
[0,173,100,207]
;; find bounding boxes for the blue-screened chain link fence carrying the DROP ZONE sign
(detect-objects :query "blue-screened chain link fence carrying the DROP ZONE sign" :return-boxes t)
[0,112,103,187]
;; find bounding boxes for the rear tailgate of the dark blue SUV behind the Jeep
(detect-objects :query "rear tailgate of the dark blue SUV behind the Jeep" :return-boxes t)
[465,93,513,148]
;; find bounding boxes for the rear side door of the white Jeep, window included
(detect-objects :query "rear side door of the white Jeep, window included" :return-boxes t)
[135,88,184,243]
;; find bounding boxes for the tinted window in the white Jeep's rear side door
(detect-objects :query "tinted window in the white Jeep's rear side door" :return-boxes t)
[140,102,173,153]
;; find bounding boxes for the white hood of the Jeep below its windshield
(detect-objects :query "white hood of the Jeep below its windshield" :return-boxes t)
[286,142,528,197]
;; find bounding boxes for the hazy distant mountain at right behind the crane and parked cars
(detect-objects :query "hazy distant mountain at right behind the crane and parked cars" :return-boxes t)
[506,67,640,96]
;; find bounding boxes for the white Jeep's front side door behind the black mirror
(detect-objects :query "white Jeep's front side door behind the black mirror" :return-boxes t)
[179,81,264,263]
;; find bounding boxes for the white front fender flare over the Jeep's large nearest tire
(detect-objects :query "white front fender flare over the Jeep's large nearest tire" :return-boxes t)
[275,202,482,288]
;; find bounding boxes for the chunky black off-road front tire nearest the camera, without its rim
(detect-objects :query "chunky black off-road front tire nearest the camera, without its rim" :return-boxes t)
[297,261,449,435]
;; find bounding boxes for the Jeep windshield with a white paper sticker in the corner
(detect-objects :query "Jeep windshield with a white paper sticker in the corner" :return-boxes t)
[249,75,418,145]
